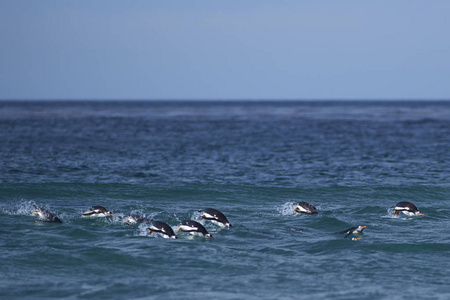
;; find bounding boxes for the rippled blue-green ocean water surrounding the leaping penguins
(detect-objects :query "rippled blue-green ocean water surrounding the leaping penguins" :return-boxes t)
[0,101,450,300]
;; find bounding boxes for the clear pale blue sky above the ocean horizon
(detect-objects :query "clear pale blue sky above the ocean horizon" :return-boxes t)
[0,0,450,100]
